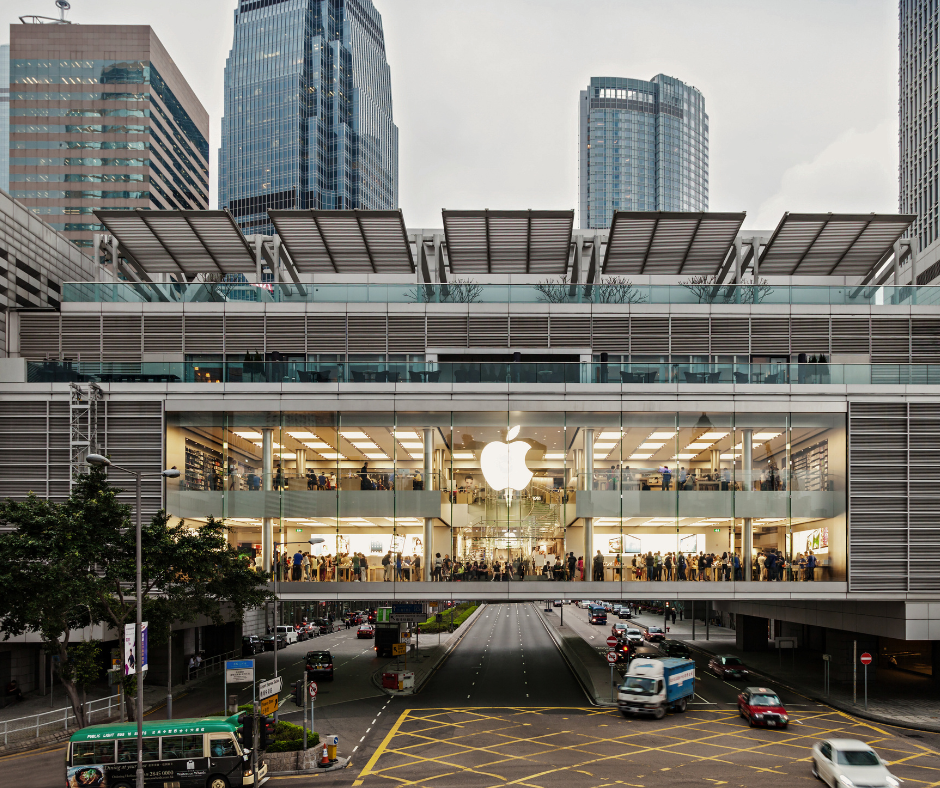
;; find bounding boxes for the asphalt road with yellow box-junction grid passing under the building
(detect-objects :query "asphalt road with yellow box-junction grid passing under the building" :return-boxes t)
[7,603,940,788]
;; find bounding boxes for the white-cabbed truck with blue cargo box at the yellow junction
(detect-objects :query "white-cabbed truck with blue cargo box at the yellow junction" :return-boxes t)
[617,657,695,720]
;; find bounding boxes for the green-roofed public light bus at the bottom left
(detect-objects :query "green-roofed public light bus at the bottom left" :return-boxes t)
[65,714,268,788]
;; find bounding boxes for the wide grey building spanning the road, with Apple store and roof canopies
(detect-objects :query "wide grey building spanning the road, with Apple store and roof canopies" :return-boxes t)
[0,205,940,676]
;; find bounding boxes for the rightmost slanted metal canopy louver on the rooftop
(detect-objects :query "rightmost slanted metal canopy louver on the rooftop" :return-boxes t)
[758,213,916,276]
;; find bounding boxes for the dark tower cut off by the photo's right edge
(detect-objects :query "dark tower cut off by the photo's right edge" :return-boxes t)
[898,0,940,284]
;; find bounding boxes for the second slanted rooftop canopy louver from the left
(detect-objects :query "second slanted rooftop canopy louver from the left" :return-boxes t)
[268,210,415,274]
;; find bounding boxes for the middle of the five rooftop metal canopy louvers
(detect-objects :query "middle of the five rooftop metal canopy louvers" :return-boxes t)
[441,210,574,276]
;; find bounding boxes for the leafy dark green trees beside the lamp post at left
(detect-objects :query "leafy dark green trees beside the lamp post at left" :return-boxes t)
[0,469,270,727]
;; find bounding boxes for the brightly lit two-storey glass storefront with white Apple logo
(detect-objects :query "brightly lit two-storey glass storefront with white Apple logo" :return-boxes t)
[166,411,847,582]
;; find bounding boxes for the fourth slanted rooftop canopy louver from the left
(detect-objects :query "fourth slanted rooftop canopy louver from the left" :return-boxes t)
[601,211,745,276]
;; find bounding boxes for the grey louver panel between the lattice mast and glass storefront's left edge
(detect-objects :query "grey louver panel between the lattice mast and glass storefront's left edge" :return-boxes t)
[99,400,163,522]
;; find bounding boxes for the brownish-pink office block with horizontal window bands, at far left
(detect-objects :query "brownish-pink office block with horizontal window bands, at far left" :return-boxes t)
[10,23,209,247]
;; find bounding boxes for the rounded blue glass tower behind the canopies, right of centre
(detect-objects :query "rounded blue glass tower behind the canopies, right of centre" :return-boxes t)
[579,74,708,228]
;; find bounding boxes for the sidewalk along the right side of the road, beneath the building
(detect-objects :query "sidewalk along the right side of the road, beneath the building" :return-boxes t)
[636,616,940,732]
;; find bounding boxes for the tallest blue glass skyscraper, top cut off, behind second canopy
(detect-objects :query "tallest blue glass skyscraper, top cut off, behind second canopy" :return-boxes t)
[219,0,398,233]
